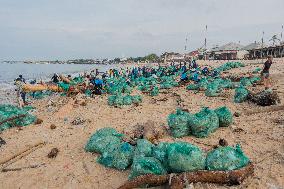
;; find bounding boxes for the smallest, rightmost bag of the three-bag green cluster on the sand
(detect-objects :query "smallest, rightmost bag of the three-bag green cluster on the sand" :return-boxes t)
[215,106,233,127]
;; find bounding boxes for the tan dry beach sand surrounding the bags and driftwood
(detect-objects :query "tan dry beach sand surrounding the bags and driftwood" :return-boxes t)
[0,60,284,189]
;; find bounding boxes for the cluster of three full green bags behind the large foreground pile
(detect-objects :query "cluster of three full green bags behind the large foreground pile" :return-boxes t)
[168,107,233,138]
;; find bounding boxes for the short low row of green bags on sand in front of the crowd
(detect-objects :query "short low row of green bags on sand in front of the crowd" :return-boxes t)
[108,94,142,106]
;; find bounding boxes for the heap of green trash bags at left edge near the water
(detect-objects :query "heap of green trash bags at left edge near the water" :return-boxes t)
[0,104,37,131]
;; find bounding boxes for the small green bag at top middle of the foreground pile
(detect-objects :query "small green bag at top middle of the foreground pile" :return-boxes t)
[134,139,154,157]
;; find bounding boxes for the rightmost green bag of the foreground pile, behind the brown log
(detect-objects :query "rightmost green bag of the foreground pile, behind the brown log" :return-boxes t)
[206,145,250,171]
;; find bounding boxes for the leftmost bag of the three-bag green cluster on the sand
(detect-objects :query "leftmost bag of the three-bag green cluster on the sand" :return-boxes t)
[168,109,191,138]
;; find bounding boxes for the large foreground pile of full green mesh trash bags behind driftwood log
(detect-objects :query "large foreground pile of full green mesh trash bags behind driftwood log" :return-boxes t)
[85,127,250,180]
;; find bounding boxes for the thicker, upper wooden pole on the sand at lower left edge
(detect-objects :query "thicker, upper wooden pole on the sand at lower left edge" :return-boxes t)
[0,141,45,170]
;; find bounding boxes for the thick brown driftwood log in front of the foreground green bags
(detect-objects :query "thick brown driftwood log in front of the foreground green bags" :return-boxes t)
[118,163,254,189]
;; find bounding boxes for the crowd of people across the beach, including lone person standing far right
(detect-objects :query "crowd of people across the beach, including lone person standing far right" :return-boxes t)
[15,56,273,106]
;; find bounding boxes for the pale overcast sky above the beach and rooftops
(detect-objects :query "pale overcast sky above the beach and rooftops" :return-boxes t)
[0,0,284,60]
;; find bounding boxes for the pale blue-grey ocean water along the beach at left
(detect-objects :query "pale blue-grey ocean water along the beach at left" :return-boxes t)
[0,62,121,104]
